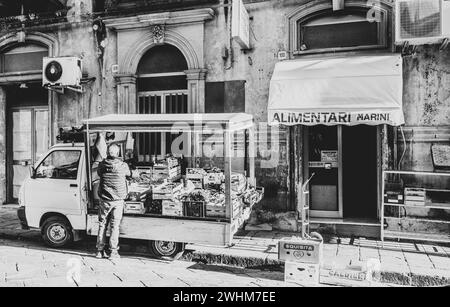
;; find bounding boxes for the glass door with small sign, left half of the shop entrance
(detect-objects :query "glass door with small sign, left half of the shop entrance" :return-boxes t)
[304,125,343,218]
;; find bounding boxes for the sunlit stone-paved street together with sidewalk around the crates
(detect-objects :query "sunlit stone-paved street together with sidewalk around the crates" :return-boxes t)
[0,206,450,287]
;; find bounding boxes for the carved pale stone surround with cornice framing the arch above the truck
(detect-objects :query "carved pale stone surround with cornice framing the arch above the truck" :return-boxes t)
[104,8,214,113]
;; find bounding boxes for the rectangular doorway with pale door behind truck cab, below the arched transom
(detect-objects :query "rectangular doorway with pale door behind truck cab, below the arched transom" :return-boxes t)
[7,85,49,203]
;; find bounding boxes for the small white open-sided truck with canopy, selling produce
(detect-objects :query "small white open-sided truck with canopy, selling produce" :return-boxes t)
[18,114,255,257]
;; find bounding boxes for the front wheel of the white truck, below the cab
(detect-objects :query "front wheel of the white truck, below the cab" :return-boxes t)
[42,216,73,248]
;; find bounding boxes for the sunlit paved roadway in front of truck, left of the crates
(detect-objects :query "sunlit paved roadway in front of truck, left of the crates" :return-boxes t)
[0,240,285,287]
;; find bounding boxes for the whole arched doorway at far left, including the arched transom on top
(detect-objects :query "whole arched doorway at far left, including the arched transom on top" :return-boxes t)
[0,42,49,202]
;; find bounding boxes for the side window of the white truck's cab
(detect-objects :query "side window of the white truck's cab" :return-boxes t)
[36,150,81,180]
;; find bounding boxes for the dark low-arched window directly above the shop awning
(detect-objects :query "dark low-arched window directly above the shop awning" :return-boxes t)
[293,8,388,54]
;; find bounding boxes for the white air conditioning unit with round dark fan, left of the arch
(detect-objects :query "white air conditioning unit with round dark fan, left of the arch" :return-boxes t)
[42,57,82,87]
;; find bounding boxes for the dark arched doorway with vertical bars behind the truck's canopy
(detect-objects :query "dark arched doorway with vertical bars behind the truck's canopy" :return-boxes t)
[136,44,189,162]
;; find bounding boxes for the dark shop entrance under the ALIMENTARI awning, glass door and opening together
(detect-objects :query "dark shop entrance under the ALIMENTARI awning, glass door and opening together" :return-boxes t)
[303,125,379,219]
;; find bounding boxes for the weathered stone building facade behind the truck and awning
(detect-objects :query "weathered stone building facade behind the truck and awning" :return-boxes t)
[0,0,450,233]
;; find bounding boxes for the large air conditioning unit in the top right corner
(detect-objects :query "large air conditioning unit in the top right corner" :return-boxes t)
[395,0,450,45]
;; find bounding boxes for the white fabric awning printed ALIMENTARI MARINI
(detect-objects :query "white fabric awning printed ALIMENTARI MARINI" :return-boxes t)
[268,55,404,126]
